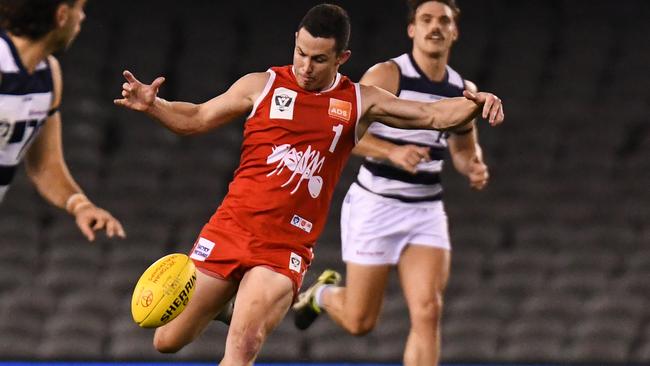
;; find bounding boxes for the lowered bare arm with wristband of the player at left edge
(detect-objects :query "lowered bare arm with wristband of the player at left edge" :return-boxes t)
[25,57,125,241]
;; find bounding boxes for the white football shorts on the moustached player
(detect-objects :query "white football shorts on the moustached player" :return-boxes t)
[341,183,451,265]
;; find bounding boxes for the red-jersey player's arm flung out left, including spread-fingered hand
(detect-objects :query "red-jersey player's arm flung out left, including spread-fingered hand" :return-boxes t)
[114,71,269,135]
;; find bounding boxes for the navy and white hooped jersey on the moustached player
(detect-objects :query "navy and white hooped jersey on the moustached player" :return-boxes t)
[357,53,465,202]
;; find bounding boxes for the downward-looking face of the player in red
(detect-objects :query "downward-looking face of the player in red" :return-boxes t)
[293,28,350,90]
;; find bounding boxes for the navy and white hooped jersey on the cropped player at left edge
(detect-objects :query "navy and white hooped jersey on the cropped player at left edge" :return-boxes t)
[0,30,54,202]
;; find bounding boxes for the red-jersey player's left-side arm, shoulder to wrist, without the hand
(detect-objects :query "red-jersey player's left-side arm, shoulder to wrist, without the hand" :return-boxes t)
[146,72,269,135]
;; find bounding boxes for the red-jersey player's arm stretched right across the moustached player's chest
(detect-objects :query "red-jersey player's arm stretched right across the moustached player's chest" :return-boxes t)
[361,85,504,130]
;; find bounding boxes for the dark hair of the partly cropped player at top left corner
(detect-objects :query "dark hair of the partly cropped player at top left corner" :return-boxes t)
[0,0,76,40]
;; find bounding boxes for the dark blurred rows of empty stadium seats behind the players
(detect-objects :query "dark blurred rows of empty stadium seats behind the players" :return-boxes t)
[0,0,650,363]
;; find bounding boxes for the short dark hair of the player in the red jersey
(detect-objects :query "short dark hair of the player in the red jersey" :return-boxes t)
[298,4,350,54]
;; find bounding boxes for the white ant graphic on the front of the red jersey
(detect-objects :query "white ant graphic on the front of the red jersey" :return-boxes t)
[266,144,325,198]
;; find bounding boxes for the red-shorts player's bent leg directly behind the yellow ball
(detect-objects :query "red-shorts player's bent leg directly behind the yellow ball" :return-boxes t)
[153,269,237,353]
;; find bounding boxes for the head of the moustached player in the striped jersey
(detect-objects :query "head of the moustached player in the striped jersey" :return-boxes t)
[408,1,458,57]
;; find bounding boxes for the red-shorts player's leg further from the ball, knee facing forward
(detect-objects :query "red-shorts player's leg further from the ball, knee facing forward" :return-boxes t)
[220,266,293,366]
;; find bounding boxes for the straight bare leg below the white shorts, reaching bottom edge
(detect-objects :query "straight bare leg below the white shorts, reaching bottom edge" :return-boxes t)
[398,245,451,366]
